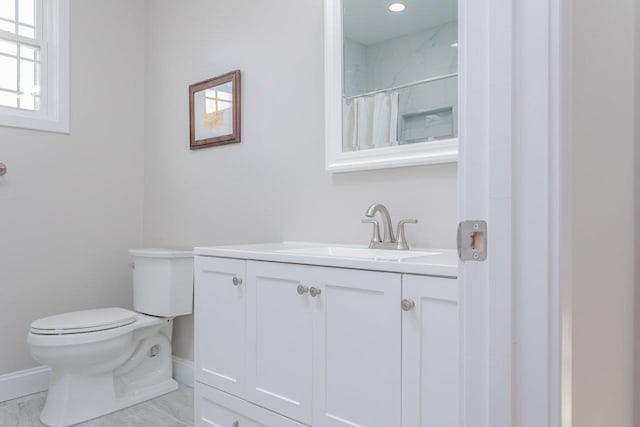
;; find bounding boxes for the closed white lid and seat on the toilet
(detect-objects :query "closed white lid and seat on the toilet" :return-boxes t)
[31,307,136,335]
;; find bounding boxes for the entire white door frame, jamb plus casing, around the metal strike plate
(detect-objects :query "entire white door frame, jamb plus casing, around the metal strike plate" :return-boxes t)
[458,0,570,427]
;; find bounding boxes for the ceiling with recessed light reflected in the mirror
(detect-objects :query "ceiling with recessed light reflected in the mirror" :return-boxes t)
[343,0,458,46]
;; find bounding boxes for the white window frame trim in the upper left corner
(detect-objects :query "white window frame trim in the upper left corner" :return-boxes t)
[0,0,69,133]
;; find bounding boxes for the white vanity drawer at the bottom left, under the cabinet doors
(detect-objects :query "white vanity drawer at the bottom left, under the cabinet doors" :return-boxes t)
[194,382,306,427]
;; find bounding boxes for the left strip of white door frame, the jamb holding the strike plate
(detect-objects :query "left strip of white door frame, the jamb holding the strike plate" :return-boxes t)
[458,0,514,427]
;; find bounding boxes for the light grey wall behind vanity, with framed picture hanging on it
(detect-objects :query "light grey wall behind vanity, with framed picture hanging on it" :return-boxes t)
[144,0,457,359]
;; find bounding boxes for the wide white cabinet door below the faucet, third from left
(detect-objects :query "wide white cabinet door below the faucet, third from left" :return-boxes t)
[310,267,401,427]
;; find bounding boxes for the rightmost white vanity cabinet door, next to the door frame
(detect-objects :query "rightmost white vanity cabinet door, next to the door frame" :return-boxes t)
[402,275,459,427]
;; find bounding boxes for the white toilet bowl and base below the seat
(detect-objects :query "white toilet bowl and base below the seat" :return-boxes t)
[32,318,178,427]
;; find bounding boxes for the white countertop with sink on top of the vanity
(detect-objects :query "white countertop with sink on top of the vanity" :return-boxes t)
[194,242,458,277]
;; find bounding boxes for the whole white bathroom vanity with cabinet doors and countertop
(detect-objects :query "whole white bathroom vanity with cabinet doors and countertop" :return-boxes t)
[195,243,459,427]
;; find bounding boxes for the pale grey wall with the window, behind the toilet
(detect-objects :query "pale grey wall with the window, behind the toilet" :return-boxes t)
[0,0,144,374]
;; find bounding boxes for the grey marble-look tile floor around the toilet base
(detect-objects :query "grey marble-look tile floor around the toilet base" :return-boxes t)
[0,385,193,427]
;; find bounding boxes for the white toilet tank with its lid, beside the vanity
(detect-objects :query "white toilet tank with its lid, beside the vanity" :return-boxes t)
[129,249,193,317]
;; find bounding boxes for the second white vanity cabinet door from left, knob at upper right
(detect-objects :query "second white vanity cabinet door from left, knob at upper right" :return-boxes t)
[247,261,312,425]
